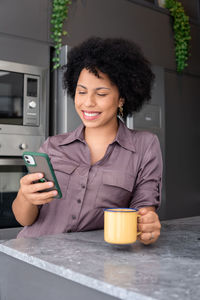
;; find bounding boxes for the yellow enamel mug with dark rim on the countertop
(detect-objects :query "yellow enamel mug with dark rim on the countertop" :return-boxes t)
[104,208,140,244]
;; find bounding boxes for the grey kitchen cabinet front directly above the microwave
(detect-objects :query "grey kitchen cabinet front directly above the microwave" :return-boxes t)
[0,0,51,68]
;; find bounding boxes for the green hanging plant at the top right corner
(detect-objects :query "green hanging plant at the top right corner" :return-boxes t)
[165,0,191,73]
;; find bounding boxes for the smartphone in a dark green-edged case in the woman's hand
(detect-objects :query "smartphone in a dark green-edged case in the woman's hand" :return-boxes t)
[22,151,62,198]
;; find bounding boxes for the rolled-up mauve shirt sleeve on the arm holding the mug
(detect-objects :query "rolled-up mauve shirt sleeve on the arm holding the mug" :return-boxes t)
[130,135,163,209]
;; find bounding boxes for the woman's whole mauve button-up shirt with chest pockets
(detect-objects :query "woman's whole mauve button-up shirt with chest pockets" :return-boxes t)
[18,121,162,237]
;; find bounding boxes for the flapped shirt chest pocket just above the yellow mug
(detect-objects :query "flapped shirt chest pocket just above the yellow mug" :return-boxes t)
[96,171,135,208]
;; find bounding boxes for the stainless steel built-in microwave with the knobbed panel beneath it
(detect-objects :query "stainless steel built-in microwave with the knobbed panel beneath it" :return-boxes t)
[0,61,48,156]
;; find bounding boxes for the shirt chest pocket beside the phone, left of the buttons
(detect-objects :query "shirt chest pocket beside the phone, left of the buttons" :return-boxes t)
[51,157,78,198]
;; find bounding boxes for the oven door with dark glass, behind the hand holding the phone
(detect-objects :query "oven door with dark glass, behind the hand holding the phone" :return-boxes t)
[0,157,27,228]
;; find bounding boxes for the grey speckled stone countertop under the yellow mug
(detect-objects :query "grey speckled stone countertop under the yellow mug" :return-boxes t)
[0,217,200,300]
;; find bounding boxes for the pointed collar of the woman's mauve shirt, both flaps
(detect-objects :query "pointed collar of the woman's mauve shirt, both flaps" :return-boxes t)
[59,120,136,152]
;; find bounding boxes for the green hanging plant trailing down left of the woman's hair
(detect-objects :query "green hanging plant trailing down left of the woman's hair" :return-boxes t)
[51,0,71,70]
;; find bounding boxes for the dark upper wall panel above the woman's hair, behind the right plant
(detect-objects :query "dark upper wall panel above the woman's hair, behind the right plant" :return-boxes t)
[64,0,200,75]
